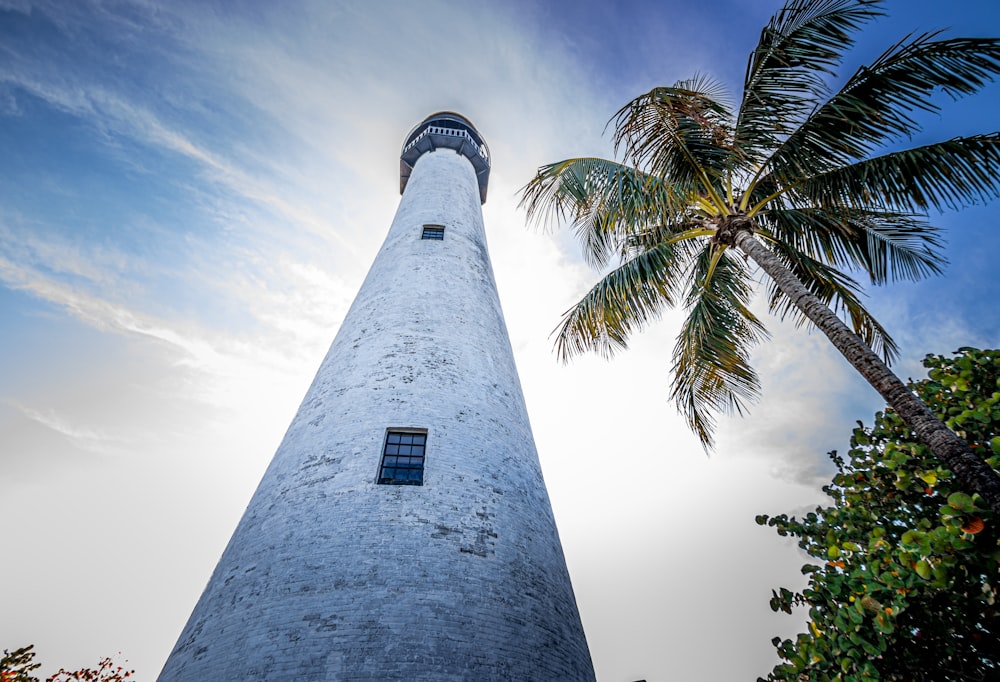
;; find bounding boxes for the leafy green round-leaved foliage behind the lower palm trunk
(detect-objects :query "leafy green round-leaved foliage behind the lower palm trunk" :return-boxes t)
[757,348,1000,682]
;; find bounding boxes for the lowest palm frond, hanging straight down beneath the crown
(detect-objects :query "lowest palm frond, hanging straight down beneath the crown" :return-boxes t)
[670,244,767,449]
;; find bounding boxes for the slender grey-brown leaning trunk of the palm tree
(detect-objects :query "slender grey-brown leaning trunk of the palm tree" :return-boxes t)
[734,229,1000,517]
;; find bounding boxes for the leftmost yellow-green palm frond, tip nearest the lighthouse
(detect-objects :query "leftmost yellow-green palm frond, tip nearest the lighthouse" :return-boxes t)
[520,158,687,267]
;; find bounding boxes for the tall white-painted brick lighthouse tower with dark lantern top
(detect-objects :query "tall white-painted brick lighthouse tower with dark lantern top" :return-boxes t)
[159,112,594,682]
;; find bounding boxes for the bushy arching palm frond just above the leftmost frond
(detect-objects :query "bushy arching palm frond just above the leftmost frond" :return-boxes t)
[612,79,734,202]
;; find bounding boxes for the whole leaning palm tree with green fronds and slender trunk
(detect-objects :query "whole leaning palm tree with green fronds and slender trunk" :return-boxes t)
[522,0,1000,513]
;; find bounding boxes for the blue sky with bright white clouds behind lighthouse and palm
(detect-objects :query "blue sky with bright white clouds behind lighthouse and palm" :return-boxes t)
[0,0,1000,682]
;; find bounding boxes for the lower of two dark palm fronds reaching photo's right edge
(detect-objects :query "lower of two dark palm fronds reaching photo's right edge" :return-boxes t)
[793,133,1000,213]
